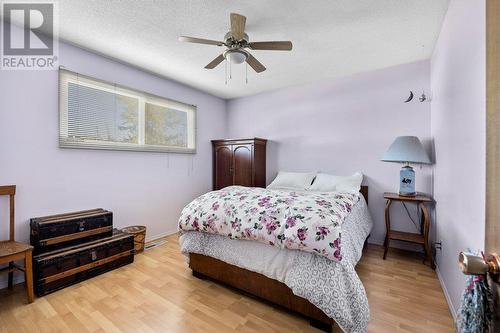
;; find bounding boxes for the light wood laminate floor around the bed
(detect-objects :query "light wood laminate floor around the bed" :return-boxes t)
[0,236,454,333]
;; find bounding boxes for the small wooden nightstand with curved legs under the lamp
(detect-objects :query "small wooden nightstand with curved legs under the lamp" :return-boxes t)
[384,192,436,269]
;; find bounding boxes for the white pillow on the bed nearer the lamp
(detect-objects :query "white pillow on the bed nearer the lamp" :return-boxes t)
[309,172,363,192]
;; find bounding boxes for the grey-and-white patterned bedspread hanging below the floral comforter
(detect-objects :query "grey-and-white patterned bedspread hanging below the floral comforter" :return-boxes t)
[180,193,373,332]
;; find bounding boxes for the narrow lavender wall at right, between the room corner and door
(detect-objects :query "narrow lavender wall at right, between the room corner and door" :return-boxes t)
[431,0,486,315]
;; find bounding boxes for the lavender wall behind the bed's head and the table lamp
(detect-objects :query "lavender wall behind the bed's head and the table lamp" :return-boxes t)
[227,61,431,243]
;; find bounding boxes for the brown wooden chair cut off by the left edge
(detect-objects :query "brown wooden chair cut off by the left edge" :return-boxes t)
[0,185,34,303]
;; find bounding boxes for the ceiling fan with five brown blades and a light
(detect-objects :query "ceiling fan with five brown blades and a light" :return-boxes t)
[179,13,292,73]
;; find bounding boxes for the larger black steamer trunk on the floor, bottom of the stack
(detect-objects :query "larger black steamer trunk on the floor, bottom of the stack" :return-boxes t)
[33,230,134,296]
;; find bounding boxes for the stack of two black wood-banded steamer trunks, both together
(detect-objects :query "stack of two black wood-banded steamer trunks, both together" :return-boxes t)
[30,208,134,296]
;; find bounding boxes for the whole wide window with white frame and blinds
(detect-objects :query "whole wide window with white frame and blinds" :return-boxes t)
[59,69,196,153]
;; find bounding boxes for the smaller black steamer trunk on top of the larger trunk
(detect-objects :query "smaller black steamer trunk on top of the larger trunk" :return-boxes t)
[30,208,113,254]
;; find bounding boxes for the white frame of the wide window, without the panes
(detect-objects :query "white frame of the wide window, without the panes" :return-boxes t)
[59,68,197,154]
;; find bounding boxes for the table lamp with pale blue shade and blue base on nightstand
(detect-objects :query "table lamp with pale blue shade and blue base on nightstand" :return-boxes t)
[382,136,431,196]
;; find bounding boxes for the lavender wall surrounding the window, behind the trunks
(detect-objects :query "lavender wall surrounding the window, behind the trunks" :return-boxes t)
[0,43,226,246]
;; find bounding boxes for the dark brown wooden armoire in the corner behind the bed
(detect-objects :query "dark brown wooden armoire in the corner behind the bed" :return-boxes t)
[212,138,267,190]
